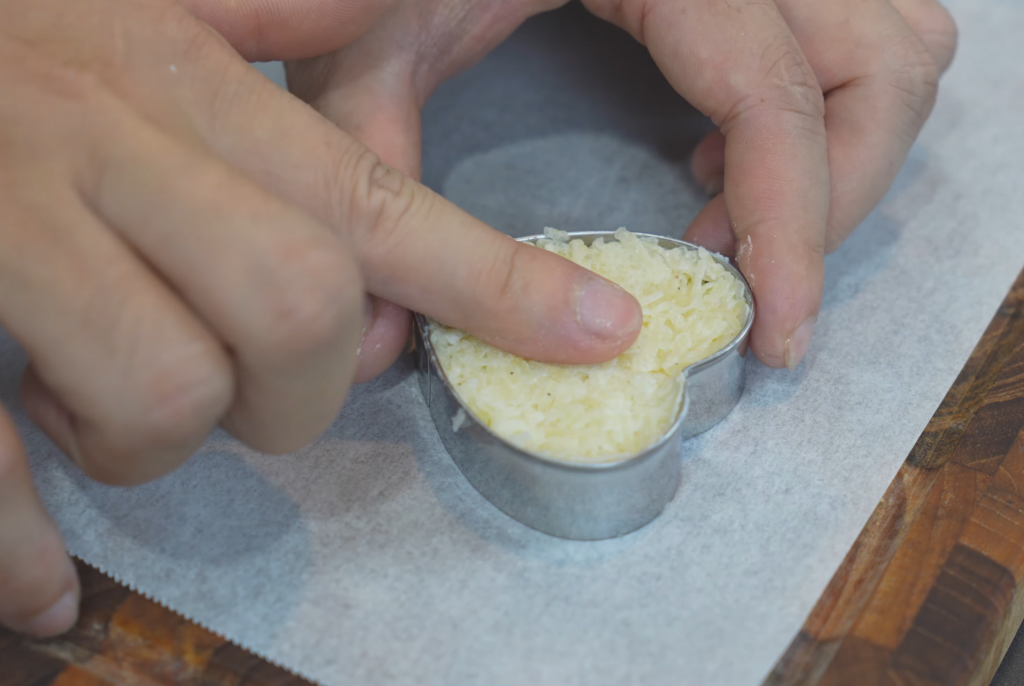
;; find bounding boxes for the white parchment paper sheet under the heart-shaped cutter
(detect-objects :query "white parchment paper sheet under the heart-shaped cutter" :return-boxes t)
[0,0,1024,686]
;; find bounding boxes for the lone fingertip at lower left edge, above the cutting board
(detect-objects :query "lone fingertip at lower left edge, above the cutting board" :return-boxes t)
[0,408,80,637]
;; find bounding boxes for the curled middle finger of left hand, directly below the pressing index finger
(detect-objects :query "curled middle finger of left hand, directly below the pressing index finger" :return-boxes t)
[89,110,364,453]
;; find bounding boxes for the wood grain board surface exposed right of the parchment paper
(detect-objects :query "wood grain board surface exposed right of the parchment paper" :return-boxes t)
[765,266,1024,686]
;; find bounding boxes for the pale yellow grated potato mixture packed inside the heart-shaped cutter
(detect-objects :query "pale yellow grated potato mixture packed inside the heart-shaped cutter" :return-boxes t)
[430,228,748,463]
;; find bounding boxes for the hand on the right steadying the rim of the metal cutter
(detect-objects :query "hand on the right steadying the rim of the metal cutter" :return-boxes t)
[289,0,956,369]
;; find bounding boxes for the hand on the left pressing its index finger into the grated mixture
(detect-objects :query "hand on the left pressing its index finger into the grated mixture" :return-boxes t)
[0,0,640,635]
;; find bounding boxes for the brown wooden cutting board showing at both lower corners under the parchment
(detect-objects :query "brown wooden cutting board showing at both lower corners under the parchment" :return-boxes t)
[6,272,1024,686]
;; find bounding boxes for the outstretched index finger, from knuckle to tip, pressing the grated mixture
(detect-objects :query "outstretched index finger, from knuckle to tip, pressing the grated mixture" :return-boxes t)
[343,164,642,363]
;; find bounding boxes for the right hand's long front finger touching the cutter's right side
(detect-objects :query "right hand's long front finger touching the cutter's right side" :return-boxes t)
[587,0,828,368]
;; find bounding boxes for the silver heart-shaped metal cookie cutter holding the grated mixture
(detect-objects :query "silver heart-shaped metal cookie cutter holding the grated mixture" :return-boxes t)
[416,231,754,541]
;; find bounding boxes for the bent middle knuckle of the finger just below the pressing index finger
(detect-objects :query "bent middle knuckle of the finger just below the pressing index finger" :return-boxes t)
[254,239,362,361]
